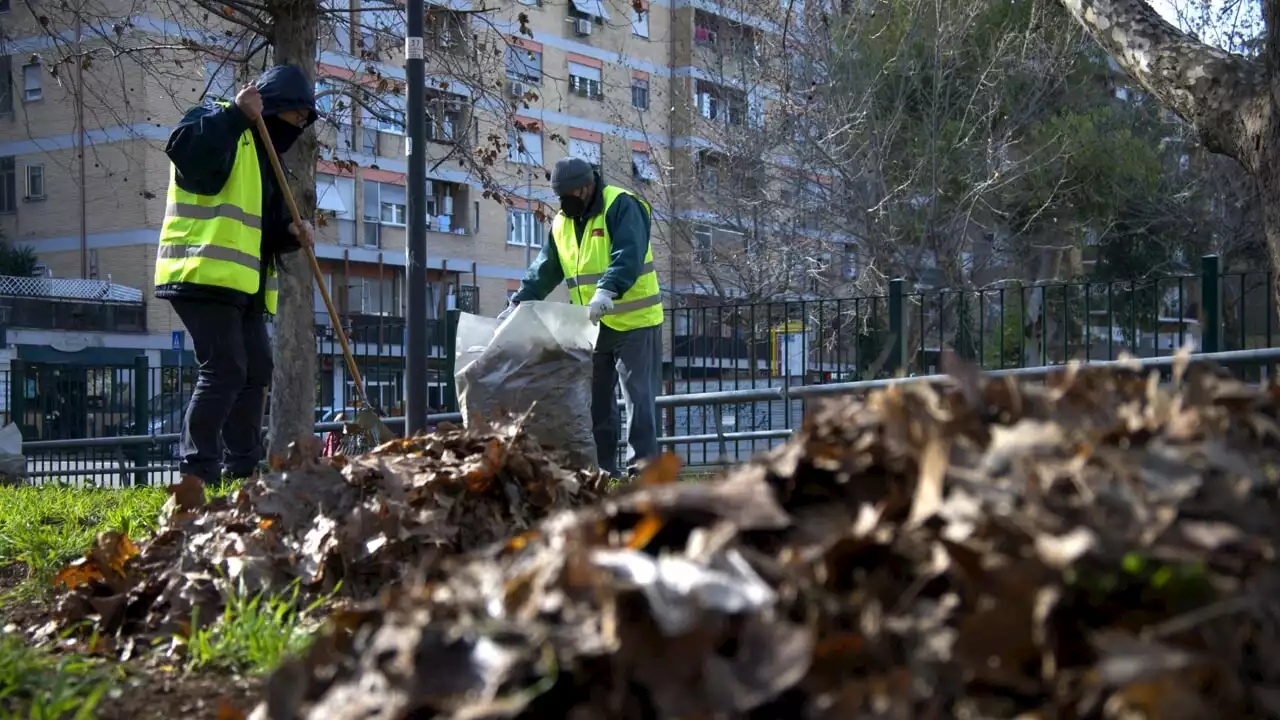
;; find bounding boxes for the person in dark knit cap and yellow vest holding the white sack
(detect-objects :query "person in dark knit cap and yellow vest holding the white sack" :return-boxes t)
[498,158,663,478]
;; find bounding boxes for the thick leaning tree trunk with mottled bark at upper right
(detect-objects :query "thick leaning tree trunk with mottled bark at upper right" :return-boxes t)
[1061,0,1280,304]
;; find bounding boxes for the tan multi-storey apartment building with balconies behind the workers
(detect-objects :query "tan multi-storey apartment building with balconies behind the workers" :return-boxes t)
[0,0,838,407]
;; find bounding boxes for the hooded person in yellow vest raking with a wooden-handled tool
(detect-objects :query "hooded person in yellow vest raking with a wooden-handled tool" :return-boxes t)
[155,65,316,484]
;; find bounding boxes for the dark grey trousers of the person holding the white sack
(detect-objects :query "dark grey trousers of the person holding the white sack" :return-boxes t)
[591,324,662,478]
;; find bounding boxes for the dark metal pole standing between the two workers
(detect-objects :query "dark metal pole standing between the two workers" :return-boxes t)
[404,0,430,437]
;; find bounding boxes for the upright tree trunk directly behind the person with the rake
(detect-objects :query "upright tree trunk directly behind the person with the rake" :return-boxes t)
[268,0,319,456]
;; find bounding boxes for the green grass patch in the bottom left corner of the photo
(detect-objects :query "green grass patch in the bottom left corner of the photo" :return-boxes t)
[0,634,123,720]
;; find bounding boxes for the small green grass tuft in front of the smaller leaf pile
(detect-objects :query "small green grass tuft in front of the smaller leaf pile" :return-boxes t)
[175,582,337,675]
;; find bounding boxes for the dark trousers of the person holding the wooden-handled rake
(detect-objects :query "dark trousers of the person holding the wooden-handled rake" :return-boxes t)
[170,300,271,483]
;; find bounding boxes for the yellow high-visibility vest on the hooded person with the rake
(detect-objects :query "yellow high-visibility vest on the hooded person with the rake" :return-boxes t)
[155,102,280,315]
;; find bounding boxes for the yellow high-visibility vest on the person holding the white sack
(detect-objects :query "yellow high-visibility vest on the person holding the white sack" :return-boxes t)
[552,184,662,331]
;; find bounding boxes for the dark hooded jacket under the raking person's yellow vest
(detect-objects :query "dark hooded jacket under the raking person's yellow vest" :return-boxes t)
[156,65,316,307]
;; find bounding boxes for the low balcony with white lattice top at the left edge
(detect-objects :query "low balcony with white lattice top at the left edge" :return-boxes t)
[0,275,147,333]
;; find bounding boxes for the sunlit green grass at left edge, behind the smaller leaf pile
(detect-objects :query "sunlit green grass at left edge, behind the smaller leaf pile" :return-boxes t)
[0,483,237,589]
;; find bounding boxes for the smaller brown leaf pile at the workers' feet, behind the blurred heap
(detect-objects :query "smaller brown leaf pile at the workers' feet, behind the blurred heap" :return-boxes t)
[42,418,607,648]
